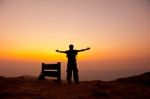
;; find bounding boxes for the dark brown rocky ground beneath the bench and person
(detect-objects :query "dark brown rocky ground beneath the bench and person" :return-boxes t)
[0,72,150,99]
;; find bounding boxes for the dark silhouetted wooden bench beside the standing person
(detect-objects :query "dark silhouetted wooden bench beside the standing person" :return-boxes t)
[39,62,61,82]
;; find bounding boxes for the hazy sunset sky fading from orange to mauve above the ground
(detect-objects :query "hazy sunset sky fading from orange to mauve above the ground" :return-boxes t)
[0,0,150,80]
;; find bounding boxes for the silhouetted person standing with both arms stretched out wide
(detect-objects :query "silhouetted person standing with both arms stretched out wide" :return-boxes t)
[56,44,90,83]
